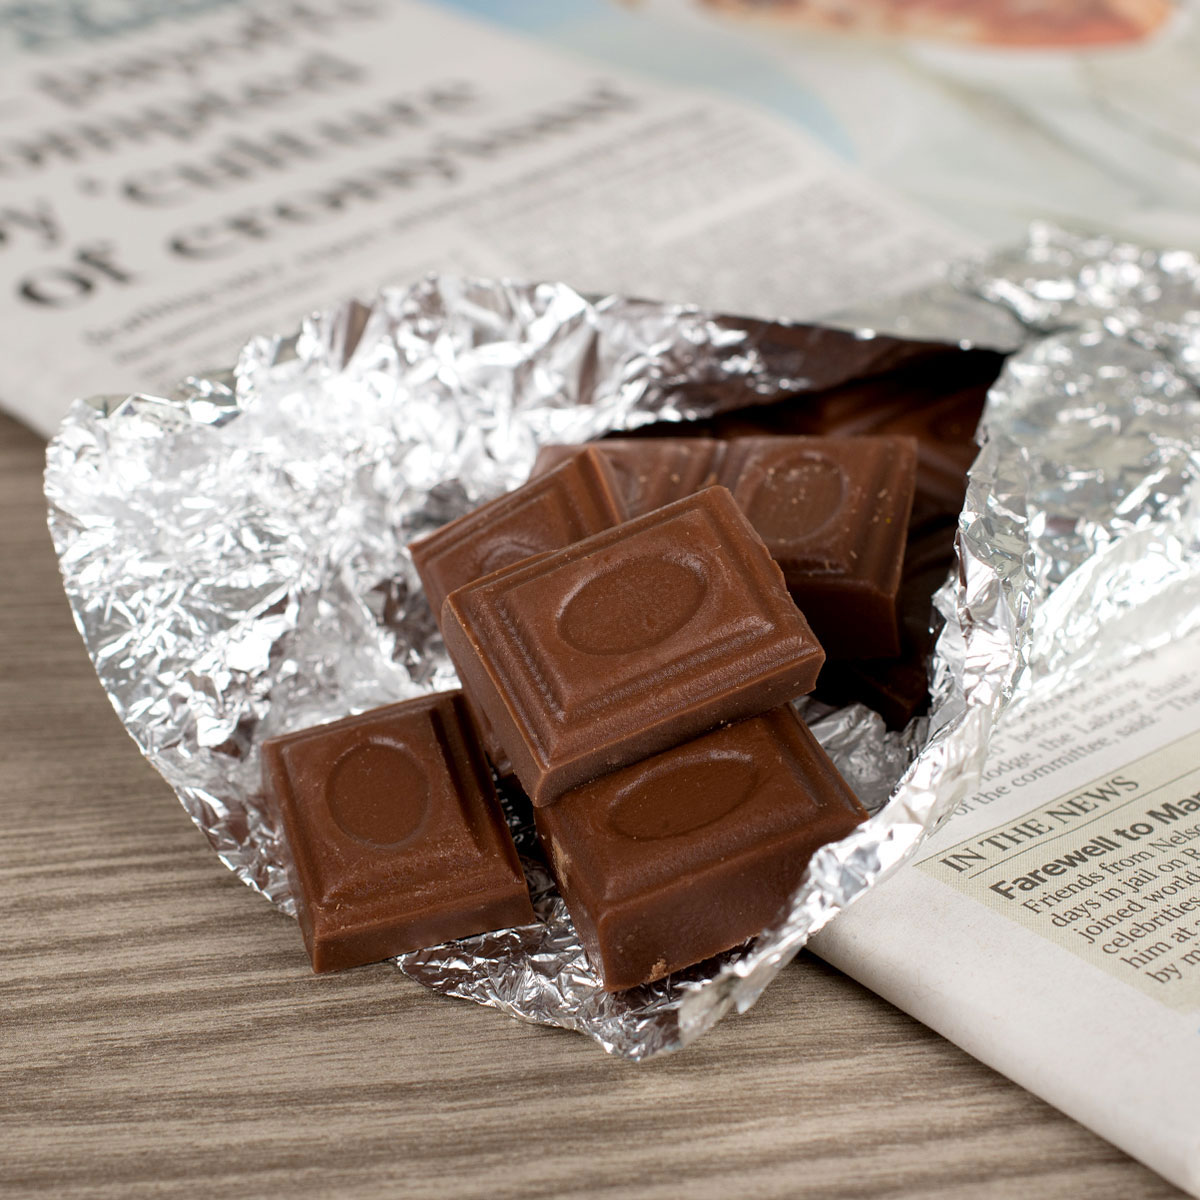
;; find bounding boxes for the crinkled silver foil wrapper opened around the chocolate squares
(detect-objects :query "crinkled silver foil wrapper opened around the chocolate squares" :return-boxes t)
[46,227,1200,1058]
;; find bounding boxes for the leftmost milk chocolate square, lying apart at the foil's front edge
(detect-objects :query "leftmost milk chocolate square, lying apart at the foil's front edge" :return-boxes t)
[263,691,534,971]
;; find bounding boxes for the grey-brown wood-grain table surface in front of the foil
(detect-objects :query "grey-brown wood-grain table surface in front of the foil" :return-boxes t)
[0,408,1183,1200]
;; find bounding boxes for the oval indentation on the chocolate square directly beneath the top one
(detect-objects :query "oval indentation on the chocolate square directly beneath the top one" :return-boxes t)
[608,754,758,841]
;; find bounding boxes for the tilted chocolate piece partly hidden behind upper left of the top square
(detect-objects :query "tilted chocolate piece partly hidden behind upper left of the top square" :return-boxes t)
[409,448,626,626]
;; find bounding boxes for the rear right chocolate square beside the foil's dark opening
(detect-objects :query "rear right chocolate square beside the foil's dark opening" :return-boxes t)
[720,437,917,659]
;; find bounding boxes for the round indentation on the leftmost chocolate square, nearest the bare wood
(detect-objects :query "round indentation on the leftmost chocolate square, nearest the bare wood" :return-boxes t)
[325,742,430,847]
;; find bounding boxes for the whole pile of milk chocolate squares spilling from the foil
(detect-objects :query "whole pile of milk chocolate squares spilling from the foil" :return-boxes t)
[264,436,936,990]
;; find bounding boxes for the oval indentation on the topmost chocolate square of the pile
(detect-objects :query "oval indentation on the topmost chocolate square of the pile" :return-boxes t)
[558,556,708,654]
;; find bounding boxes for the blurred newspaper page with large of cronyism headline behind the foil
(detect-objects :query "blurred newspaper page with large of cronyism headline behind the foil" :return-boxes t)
[0,0,974,434]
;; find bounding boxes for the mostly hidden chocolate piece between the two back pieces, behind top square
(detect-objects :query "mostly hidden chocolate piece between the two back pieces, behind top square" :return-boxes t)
[530,438,725,517]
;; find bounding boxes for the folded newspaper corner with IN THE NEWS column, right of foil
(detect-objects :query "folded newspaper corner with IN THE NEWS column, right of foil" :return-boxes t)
[810,636,1200,1195]
